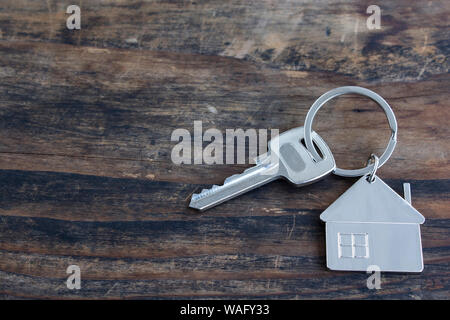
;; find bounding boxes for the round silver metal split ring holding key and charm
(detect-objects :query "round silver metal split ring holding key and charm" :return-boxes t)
[304,86,397,177]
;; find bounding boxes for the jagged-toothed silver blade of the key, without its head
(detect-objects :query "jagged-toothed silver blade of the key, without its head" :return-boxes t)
[189,163,279,211]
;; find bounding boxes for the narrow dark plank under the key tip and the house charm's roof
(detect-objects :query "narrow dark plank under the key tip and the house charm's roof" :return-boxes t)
[0,171,450,222]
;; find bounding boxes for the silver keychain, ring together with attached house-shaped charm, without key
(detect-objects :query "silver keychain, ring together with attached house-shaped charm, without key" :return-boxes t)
[304,86,425,272]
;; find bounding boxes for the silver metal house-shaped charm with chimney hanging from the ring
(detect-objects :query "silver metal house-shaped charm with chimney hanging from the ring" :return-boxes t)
[320,159,425,272]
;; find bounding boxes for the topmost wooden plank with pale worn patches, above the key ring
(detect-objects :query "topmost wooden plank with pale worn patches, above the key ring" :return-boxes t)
[0,0,450,81]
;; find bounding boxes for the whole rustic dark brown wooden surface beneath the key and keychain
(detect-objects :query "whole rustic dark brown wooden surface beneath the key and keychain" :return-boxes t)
[0,0,450,299]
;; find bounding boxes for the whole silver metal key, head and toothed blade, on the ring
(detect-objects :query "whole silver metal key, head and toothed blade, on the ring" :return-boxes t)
[189,127,336,211]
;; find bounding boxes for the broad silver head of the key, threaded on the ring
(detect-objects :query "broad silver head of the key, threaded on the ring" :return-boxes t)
[268,127,336,186]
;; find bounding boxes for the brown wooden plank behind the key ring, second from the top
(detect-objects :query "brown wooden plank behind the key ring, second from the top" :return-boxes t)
[0,42,450,183]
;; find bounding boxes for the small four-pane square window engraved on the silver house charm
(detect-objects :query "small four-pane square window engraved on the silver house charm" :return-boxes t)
[337,232,369,259]
